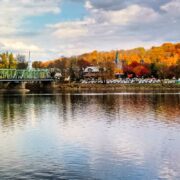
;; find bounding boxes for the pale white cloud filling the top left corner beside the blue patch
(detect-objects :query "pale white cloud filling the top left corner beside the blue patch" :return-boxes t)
[0,0,61,36]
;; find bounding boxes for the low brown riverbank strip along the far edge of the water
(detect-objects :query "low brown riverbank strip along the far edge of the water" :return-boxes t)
[0,83,180,93]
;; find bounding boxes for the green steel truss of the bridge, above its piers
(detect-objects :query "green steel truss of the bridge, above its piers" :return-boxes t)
[0,69,52,81]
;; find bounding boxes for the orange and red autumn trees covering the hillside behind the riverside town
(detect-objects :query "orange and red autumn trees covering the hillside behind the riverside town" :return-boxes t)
[33,43,180,78]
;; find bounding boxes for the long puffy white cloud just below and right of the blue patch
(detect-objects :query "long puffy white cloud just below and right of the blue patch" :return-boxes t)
[47,4,158,40]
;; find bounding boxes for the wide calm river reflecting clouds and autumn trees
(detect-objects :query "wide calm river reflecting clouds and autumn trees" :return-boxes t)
[0,93,180,180]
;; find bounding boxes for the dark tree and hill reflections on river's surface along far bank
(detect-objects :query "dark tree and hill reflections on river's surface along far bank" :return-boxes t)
[0,94,180,127]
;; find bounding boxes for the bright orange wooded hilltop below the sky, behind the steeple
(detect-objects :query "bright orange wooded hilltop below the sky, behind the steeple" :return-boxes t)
[35,43,180,67]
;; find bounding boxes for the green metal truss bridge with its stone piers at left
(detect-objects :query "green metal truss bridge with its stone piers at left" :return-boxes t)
[0,69,54,89]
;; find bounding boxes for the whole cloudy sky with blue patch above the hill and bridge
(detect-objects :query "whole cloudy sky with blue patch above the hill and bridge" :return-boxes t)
[0,0,180,60]
